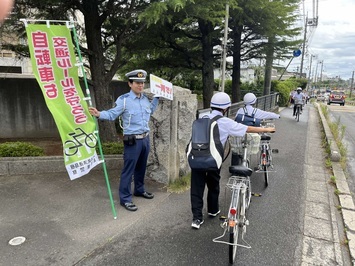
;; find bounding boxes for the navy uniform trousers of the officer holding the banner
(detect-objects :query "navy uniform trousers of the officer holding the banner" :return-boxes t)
[119,135,150,203]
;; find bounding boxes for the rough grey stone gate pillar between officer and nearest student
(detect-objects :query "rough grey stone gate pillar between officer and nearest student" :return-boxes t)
[147,86,197,184]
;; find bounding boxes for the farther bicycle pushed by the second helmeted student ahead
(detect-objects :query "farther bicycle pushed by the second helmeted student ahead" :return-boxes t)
[255,120,279,187]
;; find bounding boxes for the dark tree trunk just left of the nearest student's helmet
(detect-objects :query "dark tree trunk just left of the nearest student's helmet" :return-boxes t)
[199,20,214,108]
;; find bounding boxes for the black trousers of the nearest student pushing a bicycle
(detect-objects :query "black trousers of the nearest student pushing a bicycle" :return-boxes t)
[190,169,221,220]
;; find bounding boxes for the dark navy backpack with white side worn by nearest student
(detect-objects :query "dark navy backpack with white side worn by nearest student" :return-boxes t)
[186,115,224,170]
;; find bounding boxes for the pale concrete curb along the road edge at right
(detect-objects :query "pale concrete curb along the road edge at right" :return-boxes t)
[315,104,355,265]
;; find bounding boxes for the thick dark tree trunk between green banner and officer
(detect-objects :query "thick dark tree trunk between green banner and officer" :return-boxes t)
[83,1,117,142]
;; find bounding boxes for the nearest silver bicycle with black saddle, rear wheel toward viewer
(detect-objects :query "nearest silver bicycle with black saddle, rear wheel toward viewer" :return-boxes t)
[212,134,259,264]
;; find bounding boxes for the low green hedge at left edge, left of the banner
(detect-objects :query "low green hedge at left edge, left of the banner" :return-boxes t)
[0,141,45,157]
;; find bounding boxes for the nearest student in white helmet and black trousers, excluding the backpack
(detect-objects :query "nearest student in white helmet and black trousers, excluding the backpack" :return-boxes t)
[190,92,275,229]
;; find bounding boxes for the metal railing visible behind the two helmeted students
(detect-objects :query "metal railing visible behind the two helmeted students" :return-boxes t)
[196,93,279,119]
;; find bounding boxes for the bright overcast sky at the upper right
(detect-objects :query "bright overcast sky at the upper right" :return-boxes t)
[288,0,355,79]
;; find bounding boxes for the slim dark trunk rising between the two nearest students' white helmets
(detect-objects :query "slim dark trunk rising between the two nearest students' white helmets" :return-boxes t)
[232,27,242,103]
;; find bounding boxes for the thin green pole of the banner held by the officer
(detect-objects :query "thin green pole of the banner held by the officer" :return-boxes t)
[67,21,117,219]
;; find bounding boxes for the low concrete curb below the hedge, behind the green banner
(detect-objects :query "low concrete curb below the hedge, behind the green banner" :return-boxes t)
[0,154,123,176]
